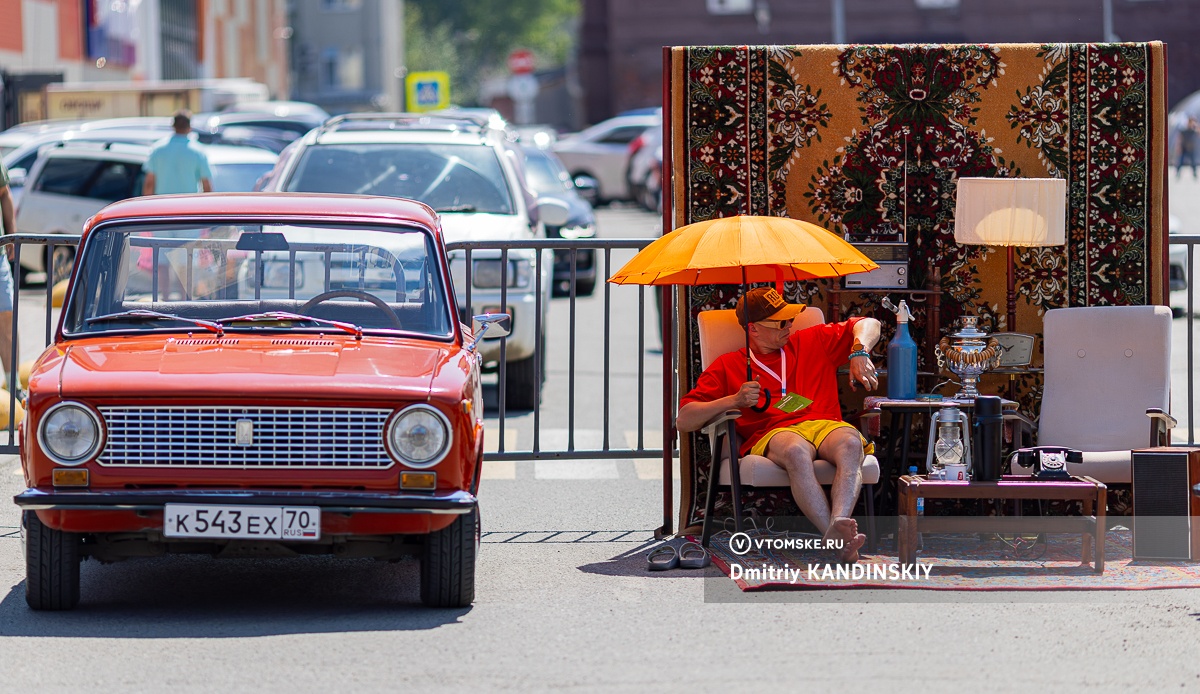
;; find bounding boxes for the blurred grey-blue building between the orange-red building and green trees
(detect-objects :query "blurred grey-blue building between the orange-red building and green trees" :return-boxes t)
[290,0,404,113]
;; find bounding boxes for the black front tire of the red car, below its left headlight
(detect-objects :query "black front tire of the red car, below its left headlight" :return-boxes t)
[22,510,79,610]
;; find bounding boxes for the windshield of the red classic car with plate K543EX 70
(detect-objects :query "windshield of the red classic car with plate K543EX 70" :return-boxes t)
[64,222,454,340]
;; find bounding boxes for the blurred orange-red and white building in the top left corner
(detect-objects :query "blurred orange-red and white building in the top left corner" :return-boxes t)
[0,0,290,126]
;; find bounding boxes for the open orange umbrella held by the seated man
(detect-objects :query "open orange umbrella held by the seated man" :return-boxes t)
[608,215,878,412]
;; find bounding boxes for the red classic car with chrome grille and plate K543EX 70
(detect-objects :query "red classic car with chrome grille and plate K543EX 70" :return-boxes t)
[16,193,509,610]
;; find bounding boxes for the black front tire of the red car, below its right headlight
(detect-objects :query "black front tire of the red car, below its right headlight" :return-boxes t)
[421,508,480,608]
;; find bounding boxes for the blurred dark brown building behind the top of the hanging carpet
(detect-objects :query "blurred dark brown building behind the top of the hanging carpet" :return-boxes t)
[578,0,1200,122]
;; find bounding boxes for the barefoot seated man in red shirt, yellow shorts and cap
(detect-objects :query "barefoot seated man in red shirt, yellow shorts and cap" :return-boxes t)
[676,287,880,562]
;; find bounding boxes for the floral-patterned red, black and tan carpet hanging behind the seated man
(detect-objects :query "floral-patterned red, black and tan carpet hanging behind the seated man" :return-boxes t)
[670,42,1165,526]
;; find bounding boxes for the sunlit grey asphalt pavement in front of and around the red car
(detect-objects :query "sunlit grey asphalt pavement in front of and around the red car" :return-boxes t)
[0,201,1200,693]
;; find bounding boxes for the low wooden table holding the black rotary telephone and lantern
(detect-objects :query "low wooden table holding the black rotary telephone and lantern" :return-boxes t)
[898,474,1108,574]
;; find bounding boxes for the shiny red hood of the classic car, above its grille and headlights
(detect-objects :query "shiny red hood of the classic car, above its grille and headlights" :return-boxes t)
[52,334,466,401]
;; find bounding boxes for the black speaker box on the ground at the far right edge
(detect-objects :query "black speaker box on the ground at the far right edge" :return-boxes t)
[1133,447,1200,561]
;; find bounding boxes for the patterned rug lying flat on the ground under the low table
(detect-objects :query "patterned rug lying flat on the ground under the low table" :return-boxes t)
[710,530,1200,591]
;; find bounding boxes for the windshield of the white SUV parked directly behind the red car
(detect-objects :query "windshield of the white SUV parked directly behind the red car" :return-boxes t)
[284,143,515,215]
